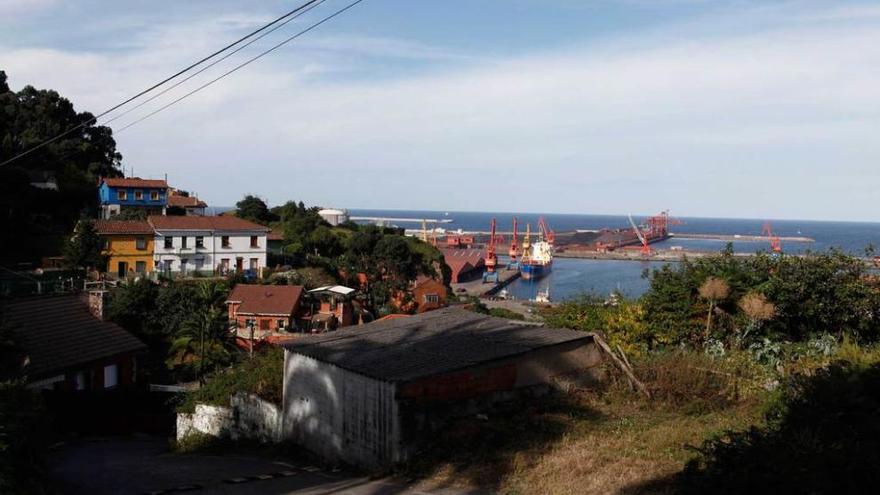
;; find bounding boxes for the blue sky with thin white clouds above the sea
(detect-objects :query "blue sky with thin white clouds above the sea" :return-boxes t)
[0,0,880,221]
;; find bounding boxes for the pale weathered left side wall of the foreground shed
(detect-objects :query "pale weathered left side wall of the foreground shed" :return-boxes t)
[282,351,402,468]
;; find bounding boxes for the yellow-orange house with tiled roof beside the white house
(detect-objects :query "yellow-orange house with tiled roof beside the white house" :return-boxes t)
[95,220,155,278]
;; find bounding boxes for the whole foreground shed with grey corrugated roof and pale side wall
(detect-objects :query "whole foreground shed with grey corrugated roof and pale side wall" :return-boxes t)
[283,308,601,468]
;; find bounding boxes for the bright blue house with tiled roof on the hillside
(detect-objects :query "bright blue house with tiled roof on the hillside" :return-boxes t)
[98,177,168,219]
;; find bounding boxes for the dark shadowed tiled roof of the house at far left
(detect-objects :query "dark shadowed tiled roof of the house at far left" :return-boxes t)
[3,294,147,378]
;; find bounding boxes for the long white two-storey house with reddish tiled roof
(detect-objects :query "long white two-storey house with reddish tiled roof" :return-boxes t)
[148,216,269,274]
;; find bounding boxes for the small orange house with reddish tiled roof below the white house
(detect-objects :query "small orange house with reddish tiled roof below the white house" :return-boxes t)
[226,284,303,339]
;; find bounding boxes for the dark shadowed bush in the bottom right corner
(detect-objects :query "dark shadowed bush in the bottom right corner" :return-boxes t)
[678,360,880,494]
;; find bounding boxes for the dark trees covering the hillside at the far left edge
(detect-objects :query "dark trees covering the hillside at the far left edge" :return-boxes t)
[0,70,122,264]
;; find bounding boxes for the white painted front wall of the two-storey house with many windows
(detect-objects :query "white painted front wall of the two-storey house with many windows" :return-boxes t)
[153,230,267,273]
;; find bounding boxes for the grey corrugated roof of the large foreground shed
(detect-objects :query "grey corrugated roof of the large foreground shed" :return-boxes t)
[284,308,593,383]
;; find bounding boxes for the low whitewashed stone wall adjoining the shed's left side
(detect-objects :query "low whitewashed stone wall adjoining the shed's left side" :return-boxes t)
[177,393,281,443]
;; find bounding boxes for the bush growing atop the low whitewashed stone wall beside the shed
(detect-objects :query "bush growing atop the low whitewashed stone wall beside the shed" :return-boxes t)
[177,347,284,413]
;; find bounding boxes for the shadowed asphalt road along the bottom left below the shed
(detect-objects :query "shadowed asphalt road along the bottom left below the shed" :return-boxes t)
[50,437,469,495]
